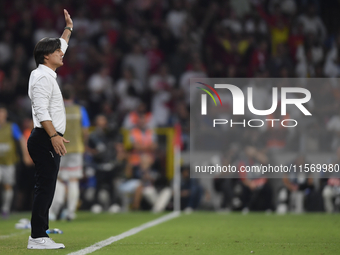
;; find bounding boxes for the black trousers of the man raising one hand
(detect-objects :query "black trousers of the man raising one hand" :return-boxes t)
[27,128,60,238]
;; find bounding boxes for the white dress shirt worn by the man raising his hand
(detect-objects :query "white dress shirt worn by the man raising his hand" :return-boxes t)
[28,38,68,134]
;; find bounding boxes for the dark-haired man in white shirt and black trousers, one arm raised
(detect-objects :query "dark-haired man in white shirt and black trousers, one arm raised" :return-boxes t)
[27,10,73,249]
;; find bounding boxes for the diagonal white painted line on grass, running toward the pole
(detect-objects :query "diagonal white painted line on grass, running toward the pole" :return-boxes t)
[67,212,180,255]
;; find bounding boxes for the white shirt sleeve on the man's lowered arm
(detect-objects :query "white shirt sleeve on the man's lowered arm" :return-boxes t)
[31,77,53,122]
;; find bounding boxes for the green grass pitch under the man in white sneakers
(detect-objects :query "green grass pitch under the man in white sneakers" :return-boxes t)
[0,212,340,255]
